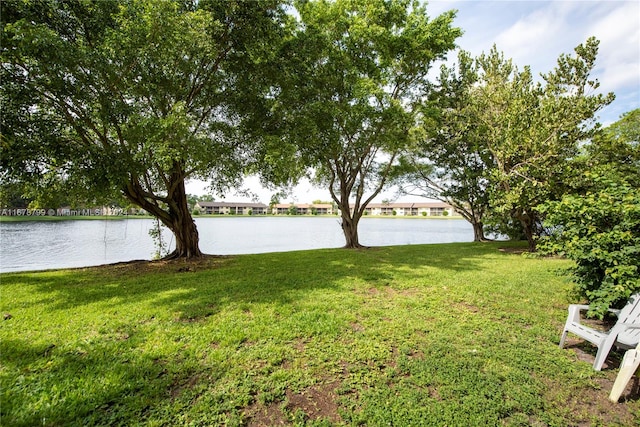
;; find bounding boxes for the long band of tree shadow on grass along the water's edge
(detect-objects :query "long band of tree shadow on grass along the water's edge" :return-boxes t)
[2,244,504,312]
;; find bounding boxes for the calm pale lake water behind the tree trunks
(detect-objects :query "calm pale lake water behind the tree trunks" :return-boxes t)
[0,217,473,272]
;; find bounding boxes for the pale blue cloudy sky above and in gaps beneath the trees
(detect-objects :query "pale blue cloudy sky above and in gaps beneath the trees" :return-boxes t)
[187,0,640,204]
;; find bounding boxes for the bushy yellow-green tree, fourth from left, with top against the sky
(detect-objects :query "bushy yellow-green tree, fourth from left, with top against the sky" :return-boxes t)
[484,38,614,250]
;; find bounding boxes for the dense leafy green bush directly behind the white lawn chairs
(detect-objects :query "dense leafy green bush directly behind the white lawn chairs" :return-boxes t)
[539,179,640,317]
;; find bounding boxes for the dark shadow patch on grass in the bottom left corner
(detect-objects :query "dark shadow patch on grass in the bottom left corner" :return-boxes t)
[0,339,182,426]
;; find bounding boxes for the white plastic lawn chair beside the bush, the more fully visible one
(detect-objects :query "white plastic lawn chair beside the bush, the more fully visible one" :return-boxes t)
[560,294,640,371]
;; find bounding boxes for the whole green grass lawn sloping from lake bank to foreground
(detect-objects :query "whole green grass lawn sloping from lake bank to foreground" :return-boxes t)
[0,243,640,426]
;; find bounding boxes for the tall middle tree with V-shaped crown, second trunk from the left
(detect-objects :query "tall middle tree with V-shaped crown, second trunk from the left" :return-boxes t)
[278,0,461,248]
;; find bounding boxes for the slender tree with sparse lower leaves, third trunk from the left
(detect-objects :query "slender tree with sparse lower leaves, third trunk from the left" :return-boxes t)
[394,51,493,241]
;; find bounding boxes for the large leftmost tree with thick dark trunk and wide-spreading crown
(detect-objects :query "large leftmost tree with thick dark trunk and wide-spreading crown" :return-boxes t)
[0,0,286,257]
